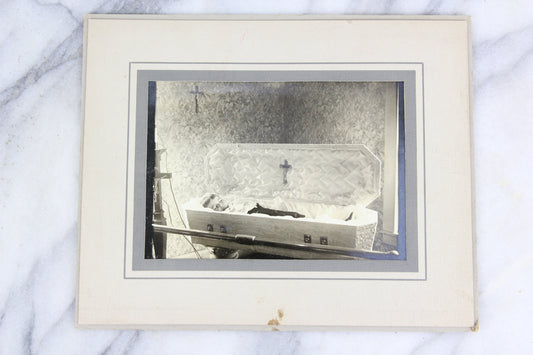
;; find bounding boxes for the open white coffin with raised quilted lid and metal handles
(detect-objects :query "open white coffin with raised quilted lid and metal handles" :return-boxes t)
[183,144,381,259]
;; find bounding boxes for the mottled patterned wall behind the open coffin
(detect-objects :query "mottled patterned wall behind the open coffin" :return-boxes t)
[156,81,396,257]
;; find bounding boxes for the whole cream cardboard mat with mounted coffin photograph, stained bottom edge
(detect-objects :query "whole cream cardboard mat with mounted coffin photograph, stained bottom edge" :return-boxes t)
[76,15,477,330]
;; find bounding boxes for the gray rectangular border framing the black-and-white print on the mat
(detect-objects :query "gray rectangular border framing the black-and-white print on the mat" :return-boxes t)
[125,66,420,280]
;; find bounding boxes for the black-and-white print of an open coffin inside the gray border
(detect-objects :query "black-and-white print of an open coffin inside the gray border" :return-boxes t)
[144,80,406,260]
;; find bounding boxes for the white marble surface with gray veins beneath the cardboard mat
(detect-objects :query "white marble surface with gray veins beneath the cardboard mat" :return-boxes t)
[0,0,533,354]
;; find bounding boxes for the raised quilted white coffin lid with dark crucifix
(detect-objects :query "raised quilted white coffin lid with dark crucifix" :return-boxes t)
[206,144,381,207]
